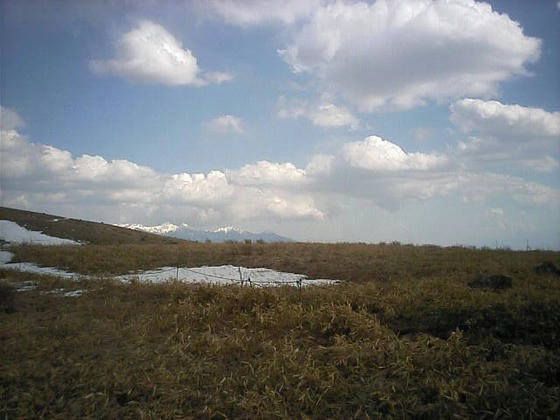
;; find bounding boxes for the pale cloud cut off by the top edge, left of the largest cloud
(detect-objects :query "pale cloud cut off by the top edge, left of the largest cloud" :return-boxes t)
[197,0,322,26]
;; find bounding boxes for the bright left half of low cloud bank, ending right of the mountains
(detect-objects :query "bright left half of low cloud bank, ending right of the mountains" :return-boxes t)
[0,111,324,223]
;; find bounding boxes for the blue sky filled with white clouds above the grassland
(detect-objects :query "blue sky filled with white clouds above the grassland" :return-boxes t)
[0,0,560,249]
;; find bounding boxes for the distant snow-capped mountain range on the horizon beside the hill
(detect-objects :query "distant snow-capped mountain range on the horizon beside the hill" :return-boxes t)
[118,223,293,242]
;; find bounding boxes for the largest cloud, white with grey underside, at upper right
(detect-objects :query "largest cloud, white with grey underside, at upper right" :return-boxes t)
[279,0,540,111]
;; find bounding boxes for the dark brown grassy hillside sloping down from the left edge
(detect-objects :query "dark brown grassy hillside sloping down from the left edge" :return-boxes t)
[0,207,182,245]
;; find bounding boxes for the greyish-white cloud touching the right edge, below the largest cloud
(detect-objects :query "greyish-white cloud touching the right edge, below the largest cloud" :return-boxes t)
[450,98,560,172]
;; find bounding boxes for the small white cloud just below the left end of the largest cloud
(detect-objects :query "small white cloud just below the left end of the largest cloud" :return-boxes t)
[276,96,359,129]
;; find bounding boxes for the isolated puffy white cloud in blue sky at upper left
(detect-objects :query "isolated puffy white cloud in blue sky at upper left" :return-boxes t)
[90,20,231,86]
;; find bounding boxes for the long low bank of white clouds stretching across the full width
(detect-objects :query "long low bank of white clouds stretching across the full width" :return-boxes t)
[0,106,560,235]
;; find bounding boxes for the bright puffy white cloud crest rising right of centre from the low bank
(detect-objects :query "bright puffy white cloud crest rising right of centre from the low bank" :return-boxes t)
[344,136,447,171]
